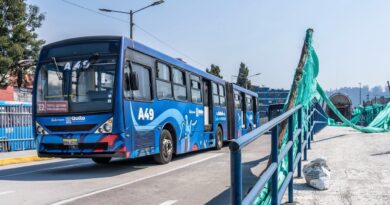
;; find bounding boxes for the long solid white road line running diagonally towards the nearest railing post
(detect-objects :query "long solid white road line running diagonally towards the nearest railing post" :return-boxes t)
[51,153,224,205]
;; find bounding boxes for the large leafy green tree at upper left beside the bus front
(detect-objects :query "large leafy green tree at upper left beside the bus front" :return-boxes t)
[0,0,45,86]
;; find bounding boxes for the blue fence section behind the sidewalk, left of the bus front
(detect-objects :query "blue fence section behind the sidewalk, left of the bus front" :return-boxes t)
[0,101,35,152]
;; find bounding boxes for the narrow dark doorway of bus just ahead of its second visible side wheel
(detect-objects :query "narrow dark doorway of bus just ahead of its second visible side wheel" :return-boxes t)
[203,80,213,132]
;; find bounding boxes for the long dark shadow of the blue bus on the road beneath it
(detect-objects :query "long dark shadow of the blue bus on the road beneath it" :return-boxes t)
[0,147,216,181]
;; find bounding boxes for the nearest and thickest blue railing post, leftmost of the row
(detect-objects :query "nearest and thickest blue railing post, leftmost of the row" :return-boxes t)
[230,149,242,205]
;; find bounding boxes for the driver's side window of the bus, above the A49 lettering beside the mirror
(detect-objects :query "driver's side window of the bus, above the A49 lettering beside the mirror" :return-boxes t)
[124,63,152,100]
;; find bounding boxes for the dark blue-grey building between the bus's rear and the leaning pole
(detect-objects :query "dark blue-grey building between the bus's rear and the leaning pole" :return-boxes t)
[252,86,290,118]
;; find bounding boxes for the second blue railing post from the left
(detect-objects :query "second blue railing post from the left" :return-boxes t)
[271,125,279,205]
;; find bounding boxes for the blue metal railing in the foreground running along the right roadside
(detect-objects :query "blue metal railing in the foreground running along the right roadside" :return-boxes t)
[230,103,327,205]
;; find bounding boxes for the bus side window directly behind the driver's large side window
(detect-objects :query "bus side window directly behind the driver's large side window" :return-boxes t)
[156,62,173,99]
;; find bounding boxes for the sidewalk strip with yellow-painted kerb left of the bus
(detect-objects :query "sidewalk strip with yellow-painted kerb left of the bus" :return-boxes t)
[0,149,50,166]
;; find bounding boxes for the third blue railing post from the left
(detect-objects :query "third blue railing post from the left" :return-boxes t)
[287,115,294,203]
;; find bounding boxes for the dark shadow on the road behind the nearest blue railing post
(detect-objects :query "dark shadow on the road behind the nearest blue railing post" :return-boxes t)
[206,155,269,205]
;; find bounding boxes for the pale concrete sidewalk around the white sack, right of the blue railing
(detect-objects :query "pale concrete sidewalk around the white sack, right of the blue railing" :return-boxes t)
[284,127,390,205]
